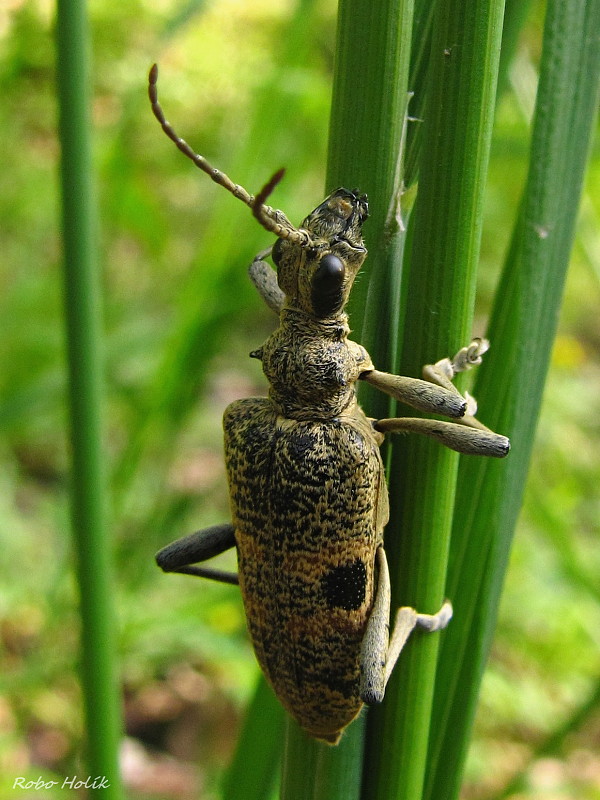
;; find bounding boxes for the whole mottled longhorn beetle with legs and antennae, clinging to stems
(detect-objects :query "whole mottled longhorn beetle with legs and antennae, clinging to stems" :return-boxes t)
[149,65,510,744]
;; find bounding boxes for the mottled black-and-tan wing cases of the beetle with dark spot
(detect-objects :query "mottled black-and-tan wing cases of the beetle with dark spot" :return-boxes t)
[224,398,388,742]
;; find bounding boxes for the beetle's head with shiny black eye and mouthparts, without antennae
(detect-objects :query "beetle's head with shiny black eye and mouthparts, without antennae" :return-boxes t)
[272,189,368,319]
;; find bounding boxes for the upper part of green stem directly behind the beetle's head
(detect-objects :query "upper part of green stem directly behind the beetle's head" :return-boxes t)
[327,0,413,386]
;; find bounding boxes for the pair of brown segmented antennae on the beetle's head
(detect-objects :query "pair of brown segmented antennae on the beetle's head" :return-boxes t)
[148,64,312,246]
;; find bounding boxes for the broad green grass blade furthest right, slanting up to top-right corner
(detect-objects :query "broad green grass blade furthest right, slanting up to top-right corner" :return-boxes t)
[426,0,600,800]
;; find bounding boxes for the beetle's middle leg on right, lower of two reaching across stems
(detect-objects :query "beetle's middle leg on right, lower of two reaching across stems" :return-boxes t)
[373,417,510,458]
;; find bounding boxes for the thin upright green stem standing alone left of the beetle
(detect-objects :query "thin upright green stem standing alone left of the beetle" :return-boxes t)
[56,0,122,800]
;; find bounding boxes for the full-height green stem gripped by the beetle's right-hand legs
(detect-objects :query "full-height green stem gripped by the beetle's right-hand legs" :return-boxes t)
[365,1,503,800]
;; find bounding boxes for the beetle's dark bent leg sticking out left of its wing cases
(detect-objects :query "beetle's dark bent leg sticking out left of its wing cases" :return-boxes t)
[156,523,239,585]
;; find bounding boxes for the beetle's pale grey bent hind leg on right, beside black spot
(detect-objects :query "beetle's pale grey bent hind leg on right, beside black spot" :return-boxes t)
[360,547,452,704]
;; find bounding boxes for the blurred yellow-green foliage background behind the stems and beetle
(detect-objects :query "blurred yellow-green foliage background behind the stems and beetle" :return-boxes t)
[0,0,600,799]
